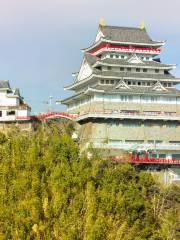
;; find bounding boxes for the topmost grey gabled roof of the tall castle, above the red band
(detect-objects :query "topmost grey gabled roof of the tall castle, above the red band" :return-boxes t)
[99,26,163,45]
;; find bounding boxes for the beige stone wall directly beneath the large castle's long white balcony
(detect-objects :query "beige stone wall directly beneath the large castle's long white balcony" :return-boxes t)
[81,120,180,143]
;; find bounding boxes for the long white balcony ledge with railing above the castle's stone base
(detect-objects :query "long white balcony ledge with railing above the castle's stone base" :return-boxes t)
[76,110,180,121]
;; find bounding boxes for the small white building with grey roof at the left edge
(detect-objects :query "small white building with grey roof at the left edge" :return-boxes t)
[0,80,31,122]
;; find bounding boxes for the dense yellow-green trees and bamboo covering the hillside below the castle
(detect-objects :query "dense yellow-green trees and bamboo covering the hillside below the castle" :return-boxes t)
[0,123,180,240]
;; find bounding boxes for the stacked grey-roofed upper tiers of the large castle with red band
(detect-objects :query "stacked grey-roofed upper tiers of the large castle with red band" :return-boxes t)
[62,23,180,104]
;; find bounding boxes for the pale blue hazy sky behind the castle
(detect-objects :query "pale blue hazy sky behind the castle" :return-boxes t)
[0,0,180,112]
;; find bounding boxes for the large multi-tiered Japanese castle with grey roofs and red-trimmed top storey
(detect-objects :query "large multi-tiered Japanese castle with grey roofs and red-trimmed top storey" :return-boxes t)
[62,22,180,159]
